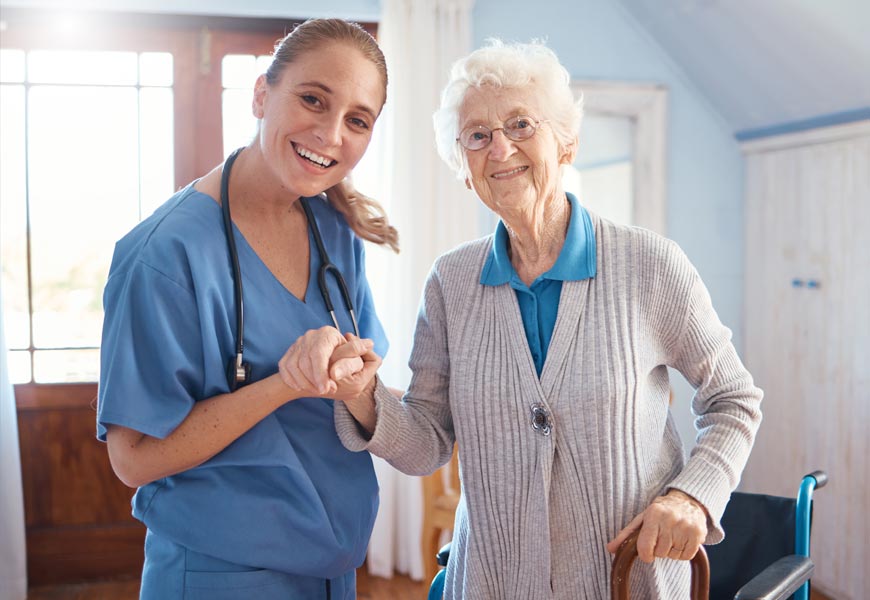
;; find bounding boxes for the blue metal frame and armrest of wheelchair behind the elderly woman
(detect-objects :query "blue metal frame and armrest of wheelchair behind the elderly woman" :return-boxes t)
[428,471,828,600]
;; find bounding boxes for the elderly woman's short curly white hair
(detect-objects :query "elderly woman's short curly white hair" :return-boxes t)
[433,38,583,179]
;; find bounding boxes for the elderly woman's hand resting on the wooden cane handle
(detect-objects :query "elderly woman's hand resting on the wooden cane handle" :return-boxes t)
[607,490,707,563]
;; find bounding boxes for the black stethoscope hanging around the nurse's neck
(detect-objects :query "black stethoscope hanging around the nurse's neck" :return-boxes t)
[221,148,360,392]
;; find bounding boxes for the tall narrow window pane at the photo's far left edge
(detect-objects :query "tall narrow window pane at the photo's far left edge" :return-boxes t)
[0,85,30,350]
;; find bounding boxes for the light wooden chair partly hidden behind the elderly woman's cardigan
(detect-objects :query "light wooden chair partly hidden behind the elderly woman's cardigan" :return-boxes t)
[421,445,459,584]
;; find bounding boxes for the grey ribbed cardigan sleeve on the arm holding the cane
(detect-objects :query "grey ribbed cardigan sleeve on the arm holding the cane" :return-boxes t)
[669,270,762,544]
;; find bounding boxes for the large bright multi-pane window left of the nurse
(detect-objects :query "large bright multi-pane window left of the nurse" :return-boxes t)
[0,49,174,382]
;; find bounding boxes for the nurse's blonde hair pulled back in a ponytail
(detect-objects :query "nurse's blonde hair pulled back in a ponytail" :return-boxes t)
[266,19,399,252]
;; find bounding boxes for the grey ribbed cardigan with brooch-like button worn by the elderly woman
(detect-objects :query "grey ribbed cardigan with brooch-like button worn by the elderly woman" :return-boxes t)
[336,214,762,600]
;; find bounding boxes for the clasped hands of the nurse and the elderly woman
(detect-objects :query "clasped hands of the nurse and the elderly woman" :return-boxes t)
[278,326,382,401]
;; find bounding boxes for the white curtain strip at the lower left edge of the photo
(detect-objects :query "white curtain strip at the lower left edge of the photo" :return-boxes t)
[0,294,27,600]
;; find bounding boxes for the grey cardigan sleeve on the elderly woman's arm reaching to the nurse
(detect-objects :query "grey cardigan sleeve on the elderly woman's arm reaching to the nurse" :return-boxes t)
[335,263,455,475]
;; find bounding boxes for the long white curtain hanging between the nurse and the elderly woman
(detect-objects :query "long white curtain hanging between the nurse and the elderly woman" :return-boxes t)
[355,0,481,580]
